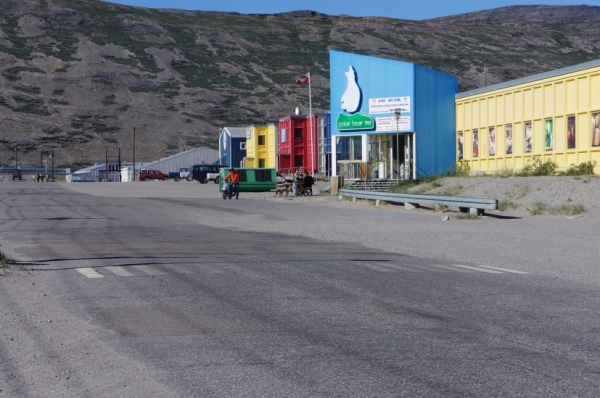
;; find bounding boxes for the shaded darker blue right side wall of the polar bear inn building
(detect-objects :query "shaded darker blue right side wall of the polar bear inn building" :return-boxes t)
[413,65,458,179]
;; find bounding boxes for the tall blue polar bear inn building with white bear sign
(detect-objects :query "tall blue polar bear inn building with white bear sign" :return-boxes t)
[329,51,458,180]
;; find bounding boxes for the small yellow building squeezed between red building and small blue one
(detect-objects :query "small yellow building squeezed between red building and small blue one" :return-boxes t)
[244,124,277,168]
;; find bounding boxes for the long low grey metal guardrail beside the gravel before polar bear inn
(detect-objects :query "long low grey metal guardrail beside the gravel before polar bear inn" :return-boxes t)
[339,189,498,214]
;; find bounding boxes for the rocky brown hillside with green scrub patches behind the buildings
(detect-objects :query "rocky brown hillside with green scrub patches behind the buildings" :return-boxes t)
[0,0,600,166]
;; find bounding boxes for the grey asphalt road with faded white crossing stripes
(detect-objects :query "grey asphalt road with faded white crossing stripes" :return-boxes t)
[0,182,600,397]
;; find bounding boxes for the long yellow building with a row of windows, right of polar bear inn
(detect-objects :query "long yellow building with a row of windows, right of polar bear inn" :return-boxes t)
[456,60,600,173]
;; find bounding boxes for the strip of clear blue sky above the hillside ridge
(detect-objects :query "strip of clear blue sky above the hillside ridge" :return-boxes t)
[102,0,600,20]
